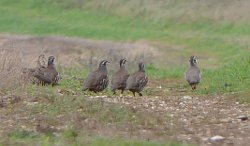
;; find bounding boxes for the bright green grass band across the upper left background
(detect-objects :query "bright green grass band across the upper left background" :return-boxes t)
[0,1,164,40]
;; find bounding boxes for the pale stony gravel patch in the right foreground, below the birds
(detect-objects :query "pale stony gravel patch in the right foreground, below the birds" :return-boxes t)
[89,95,250,146]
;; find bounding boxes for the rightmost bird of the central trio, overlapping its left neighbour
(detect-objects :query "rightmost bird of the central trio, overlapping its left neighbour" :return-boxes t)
[126,63,148,96]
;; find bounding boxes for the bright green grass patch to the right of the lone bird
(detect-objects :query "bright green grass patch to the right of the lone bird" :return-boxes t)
[201,57,250,94]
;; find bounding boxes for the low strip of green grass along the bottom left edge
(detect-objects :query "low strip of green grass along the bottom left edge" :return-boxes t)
[4,130,188,146]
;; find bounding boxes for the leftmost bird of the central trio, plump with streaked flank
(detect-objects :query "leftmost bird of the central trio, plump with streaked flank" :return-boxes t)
[83,60,109,93]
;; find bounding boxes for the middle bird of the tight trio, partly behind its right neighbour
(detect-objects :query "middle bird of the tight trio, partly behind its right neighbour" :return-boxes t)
[111,59,129,95]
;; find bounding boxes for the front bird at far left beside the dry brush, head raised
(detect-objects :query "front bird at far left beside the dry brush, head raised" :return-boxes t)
[34,56,61,85]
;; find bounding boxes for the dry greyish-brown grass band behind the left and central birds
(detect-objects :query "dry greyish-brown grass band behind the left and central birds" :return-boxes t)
[0,35,160,72]
